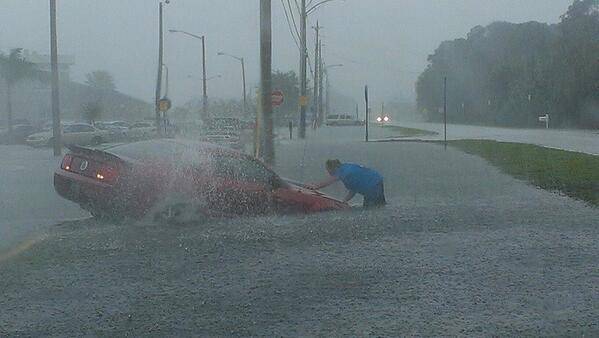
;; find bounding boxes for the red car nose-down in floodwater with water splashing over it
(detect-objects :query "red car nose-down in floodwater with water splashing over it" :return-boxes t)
[54,139,349,220]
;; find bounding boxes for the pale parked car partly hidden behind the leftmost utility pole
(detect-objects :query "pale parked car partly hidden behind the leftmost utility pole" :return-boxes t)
[25,123,110,147]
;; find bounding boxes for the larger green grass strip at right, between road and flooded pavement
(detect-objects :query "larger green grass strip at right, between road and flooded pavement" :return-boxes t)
[449,140,599,206]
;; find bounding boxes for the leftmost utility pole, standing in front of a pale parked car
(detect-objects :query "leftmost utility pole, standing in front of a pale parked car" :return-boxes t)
[50,0,62,156]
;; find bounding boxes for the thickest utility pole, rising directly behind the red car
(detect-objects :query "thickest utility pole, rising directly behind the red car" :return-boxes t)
[260,0,275,165]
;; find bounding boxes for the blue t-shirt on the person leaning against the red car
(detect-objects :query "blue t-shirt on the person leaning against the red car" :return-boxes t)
[333,163,383,195]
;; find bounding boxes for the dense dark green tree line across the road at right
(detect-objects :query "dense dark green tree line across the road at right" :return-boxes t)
[416,0,599,128]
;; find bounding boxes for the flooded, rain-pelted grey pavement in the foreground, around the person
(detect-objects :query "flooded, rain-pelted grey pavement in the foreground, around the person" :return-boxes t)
[0,128,599,336]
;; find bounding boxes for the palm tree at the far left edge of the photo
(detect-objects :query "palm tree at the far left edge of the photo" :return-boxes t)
[0,48,38,141]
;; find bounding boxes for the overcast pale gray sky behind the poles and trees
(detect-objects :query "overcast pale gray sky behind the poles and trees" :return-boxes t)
[0,0,572,104]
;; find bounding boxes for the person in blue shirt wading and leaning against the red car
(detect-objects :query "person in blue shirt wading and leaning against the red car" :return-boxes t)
[309,160,387,208]
